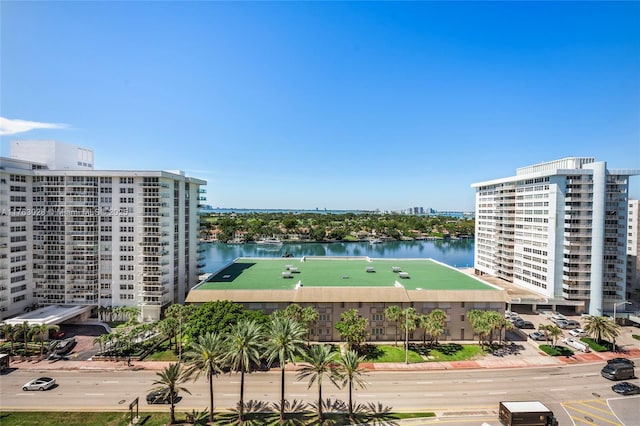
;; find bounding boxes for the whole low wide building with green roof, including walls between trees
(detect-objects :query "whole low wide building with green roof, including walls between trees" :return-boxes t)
[186,257,506,341]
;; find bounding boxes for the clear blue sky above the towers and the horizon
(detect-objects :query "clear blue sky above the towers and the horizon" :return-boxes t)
[0,1,640,210]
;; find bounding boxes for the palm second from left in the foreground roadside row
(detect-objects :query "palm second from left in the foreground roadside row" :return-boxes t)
[184,333,224,423]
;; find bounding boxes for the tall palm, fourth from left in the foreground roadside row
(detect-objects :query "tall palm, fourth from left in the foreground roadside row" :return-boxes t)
[265,316,305,421]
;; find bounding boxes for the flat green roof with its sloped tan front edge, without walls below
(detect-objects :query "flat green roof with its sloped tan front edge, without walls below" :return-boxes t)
[187,257,506,303]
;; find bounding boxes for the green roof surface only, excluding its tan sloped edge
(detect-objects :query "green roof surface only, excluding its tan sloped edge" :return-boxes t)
[192,258,493,290]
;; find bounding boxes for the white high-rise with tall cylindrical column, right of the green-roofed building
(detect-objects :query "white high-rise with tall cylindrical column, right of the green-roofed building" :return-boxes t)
[472,157,640,315]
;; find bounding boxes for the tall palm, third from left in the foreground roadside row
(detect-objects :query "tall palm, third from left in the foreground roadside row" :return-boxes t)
[225,319,263,423]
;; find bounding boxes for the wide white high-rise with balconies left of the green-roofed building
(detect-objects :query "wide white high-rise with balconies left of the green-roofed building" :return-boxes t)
[0,141,206,320]
